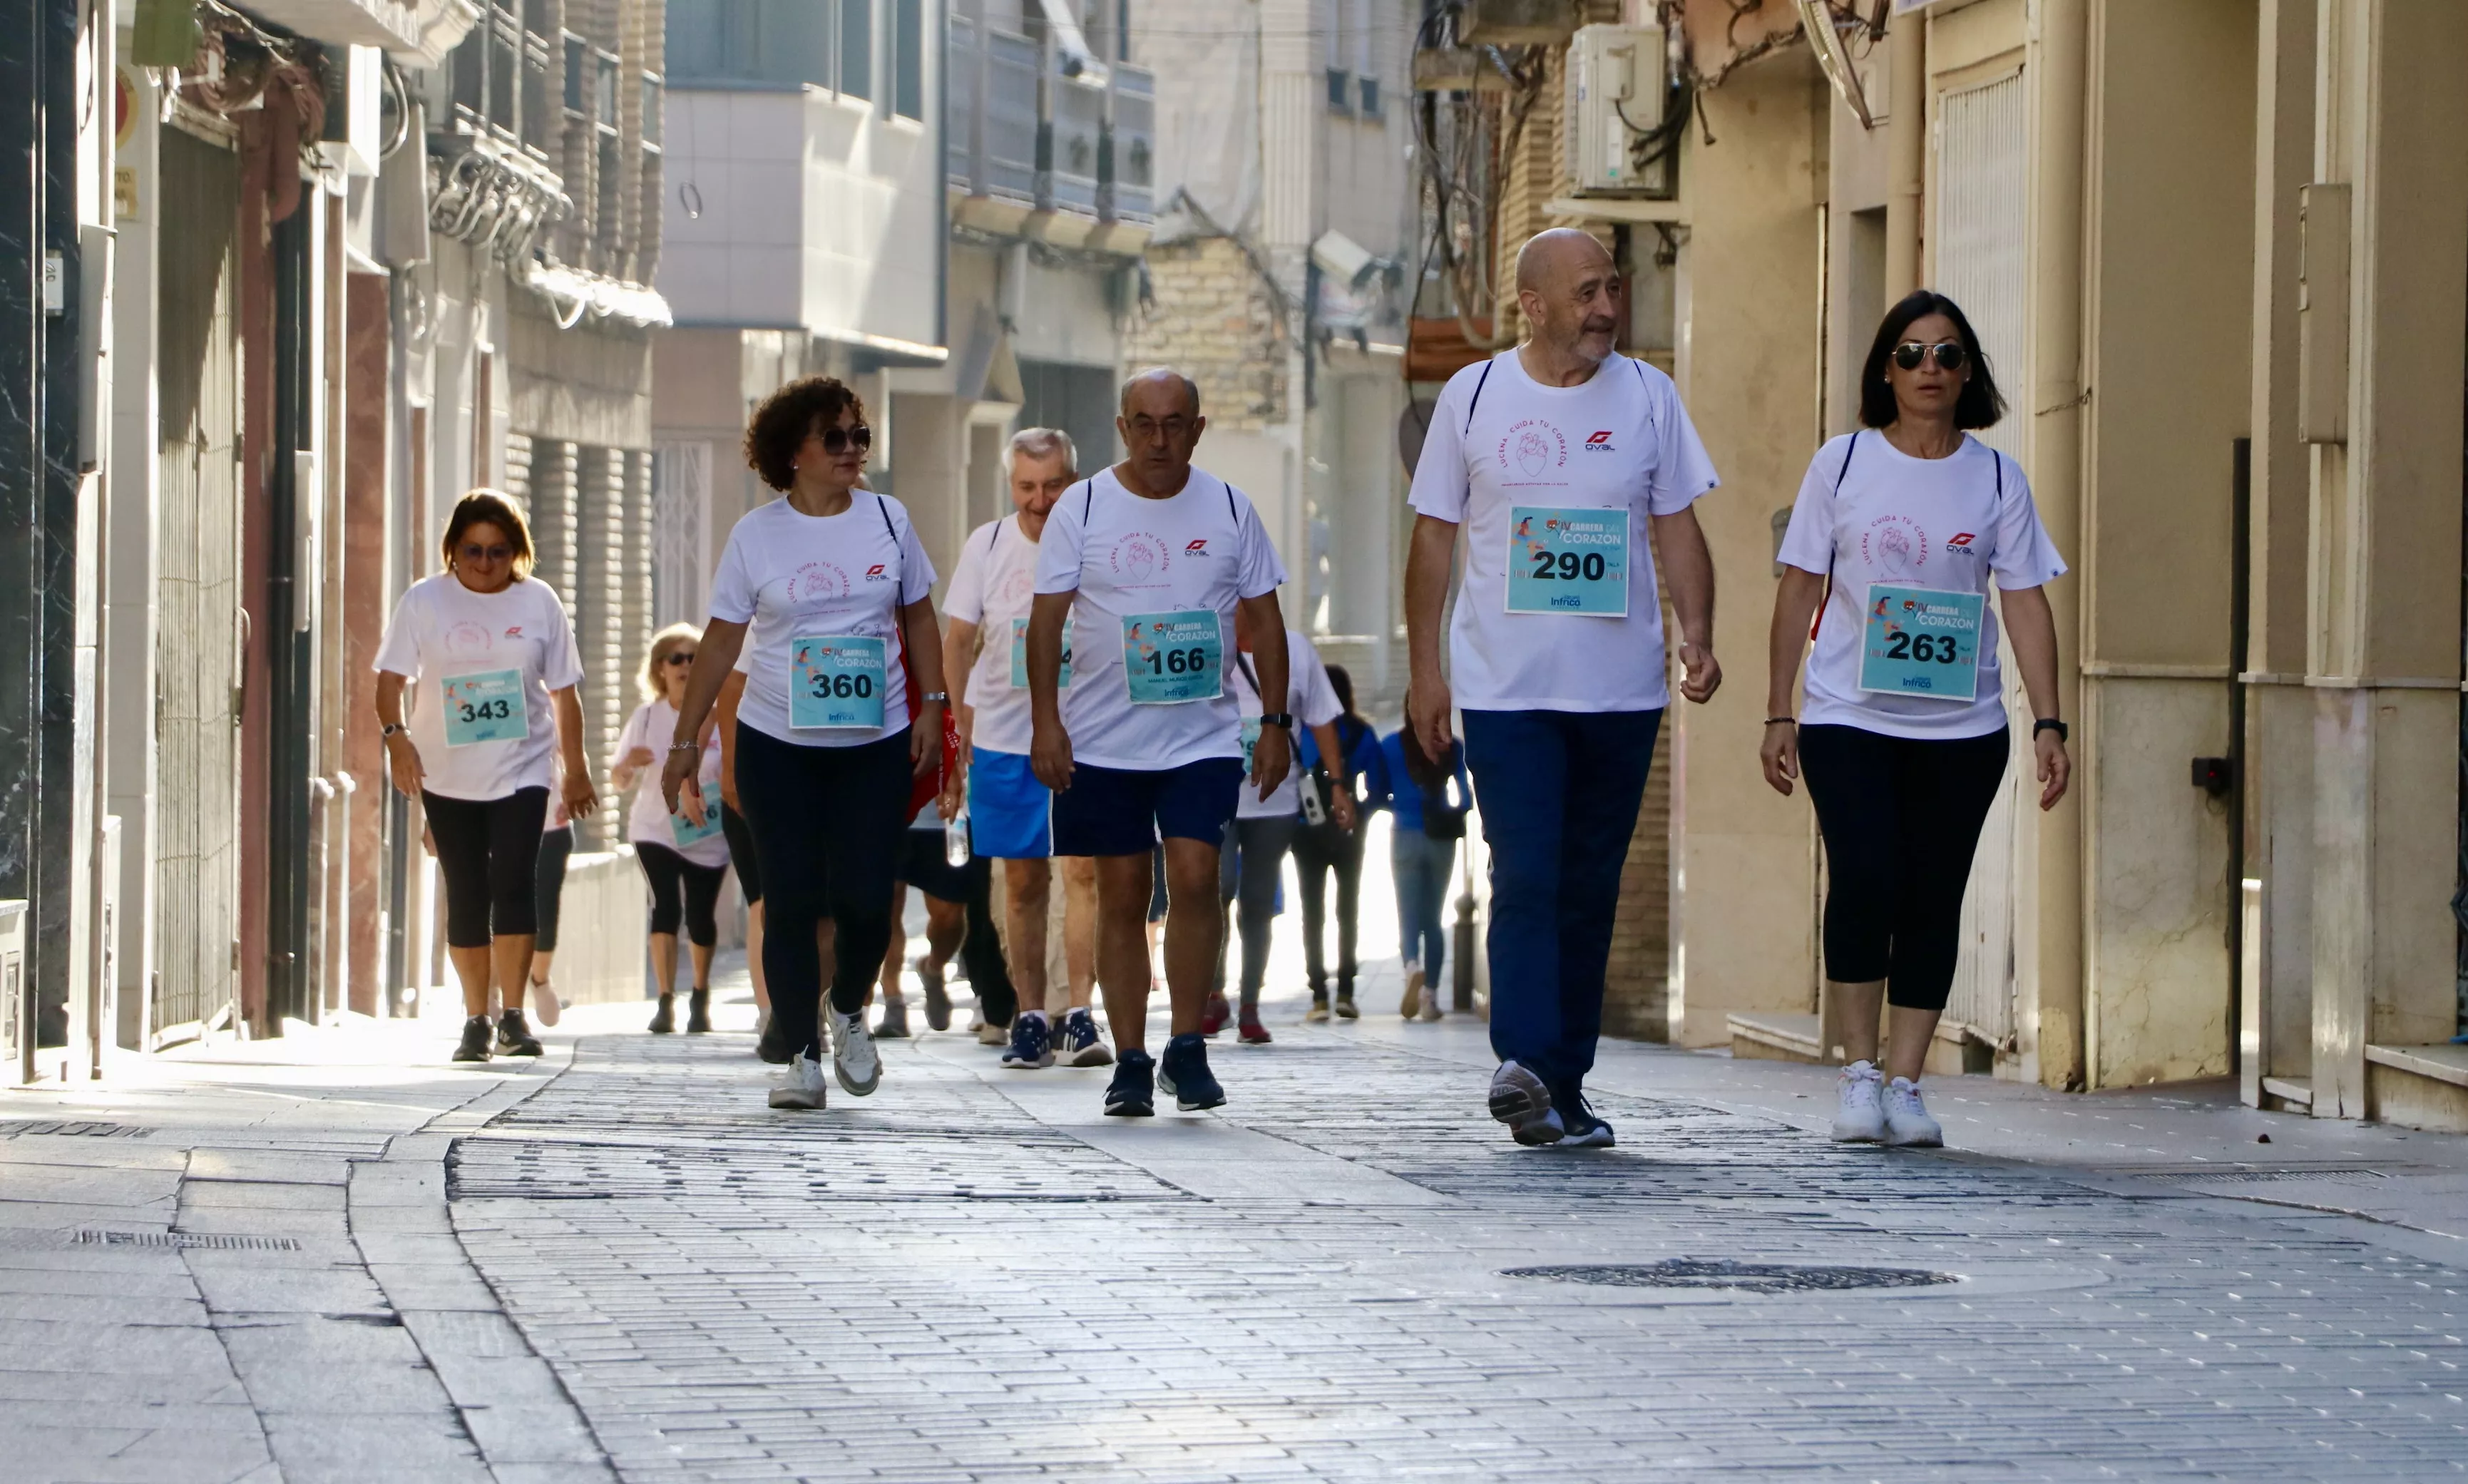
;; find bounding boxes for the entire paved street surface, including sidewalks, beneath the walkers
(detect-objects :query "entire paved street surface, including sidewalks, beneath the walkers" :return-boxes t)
[14,953,2468,1484]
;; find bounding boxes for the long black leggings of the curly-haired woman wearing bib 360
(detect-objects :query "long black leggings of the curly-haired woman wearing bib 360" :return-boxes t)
[738,726,911,1059]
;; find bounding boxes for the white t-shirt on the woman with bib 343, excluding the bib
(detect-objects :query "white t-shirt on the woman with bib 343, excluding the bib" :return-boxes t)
[370,573,583,800]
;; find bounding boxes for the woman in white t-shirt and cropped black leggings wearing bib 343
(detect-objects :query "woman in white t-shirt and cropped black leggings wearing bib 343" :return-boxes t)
[375,489,600,1062]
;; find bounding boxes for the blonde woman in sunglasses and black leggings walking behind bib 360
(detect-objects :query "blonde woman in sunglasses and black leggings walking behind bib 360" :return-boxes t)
[610,625,728,1035]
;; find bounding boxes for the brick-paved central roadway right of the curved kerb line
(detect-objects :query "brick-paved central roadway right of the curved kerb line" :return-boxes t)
[446,1013,2468,1482]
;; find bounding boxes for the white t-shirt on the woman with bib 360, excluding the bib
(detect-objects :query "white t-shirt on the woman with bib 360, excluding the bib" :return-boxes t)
[711,489,933,748]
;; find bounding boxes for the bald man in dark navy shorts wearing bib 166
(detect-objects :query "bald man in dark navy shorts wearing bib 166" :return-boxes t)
[1027,370,1294,1119]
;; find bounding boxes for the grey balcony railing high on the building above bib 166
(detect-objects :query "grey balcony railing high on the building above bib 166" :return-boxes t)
[943,15,1157,222]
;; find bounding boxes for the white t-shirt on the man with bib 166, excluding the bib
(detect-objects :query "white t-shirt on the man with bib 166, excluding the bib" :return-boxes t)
[1037,469,1286,773]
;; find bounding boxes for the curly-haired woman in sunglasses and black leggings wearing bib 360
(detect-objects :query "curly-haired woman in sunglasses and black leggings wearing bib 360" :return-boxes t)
[662,375,948,1109]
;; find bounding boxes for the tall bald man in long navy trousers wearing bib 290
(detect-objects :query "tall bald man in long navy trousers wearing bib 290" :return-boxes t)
[1407,227,1723,1146]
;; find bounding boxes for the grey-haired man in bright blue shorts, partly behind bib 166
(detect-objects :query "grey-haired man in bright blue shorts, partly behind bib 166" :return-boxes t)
[943,427,1113,1069]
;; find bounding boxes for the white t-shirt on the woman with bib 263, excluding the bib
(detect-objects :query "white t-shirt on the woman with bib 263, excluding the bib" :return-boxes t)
[1779,429,2066,738]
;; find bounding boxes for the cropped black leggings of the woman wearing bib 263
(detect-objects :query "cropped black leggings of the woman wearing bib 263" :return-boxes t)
[1799,726,2012,1010]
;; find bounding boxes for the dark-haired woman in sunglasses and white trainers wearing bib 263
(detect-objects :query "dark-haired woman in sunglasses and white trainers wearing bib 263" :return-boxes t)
[1762,289,2073,1146]
